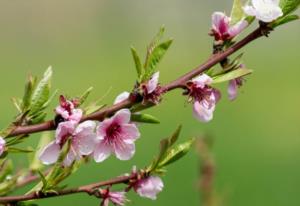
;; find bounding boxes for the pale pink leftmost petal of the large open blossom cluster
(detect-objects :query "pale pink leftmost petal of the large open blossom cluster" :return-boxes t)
[39,141,60,165]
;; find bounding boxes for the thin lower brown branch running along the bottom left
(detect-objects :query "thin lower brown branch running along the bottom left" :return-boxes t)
[0,174,137,204]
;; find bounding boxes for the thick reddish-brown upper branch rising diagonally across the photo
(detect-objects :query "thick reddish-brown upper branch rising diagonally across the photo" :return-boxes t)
[8,26,265,137]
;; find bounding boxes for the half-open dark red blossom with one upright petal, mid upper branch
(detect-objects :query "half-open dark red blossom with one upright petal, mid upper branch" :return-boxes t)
[141,72,163,104]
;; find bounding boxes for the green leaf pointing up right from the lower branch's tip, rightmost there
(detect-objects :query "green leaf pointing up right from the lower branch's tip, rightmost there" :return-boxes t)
[158,138,195,168]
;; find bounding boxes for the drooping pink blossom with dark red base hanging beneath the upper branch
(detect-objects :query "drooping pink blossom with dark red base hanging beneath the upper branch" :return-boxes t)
[187,74,221,122]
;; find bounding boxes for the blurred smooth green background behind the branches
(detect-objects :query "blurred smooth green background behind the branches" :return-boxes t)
[0,0,300,206]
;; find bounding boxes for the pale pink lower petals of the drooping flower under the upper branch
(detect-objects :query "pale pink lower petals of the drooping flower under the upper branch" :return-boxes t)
[193,100,215,122]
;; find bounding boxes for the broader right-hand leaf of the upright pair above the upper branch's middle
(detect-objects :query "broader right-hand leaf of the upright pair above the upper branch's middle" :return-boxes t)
[142,39,173,81]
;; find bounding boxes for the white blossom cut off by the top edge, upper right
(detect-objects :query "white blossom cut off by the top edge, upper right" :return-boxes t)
[243,0,283,23]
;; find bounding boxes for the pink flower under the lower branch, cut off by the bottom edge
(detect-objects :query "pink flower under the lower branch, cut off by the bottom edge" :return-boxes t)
[100,188,127,206]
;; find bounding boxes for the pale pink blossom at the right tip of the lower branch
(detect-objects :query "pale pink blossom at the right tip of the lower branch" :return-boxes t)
[133,176,164,200]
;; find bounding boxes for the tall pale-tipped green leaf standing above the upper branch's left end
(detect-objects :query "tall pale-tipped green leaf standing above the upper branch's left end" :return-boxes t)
[30,67,52,114]
